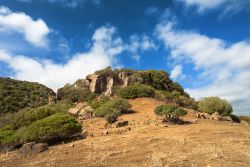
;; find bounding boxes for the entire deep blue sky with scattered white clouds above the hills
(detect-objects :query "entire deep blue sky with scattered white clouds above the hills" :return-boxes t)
[0,0,250,115]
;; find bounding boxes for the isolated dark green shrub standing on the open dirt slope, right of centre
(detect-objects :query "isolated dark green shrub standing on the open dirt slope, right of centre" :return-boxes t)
[154,104,187,122]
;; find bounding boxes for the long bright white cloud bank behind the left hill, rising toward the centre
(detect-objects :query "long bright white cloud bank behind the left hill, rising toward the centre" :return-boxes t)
[0,27,124,90]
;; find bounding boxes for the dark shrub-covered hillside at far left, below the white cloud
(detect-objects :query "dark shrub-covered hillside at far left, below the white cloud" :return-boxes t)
[0,78,55,115]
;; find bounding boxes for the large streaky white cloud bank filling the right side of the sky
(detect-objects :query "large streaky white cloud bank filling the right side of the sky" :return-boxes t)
[156,22,250,115]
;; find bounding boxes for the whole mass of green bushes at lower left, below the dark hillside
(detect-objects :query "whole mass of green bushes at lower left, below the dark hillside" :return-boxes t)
[0,102,81,150]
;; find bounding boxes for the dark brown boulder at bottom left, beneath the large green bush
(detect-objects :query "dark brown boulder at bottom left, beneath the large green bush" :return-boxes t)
[19,142,49,154]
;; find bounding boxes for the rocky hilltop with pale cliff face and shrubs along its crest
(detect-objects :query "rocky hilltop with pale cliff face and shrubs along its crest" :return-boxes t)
[58,67,185,96]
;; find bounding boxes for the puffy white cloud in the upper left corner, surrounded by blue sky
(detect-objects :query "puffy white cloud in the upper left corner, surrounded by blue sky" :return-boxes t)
[0,6,50,47]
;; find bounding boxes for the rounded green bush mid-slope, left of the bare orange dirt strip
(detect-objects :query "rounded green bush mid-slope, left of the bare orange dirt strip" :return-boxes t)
[94,98,131,117]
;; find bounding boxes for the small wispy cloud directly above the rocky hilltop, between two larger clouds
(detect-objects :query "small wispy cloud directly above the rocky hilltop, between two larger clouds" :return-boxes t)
[126,35,157,62]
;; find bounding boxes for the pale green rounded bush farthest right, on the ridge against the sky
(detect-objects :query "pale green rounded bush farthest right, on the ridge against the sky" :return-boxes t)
[198,97,233,116]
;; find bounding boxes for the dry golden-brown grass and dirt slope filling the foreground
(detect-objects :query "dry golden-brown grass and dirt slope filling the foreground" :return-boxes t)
[0,98,250,167]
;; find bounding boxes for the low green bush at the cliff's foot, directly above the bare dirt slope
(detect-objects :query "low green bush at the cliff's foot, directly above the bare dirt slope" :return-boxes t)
[119,84,155,99]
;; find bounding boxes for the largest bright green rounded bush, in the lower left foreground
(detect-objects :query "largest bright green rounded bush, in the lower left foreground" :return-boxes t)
[23,113,82,143]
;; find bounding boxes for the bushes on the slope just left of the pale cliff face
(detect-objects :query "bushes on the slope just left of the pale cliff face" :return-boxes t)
[57,81,97,103]
